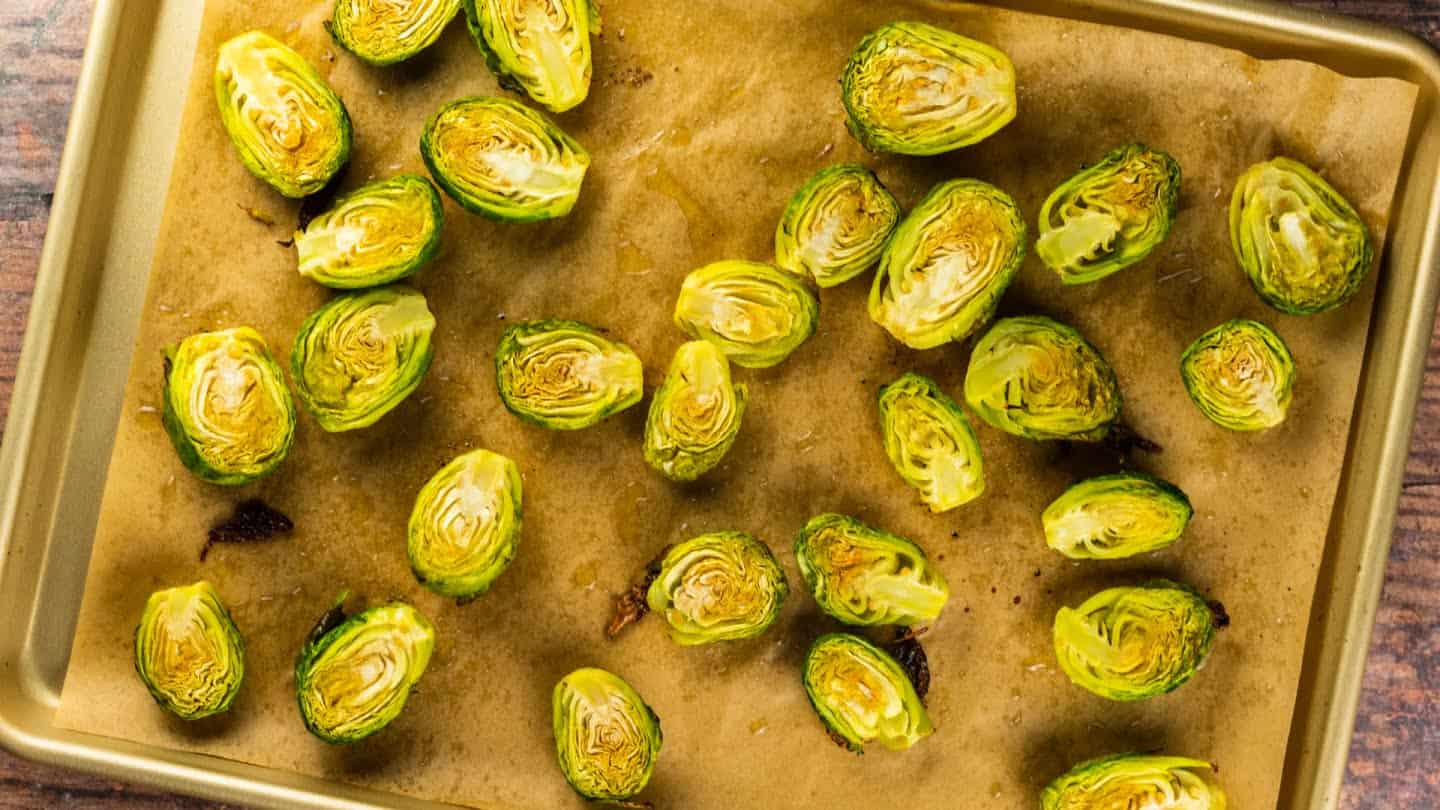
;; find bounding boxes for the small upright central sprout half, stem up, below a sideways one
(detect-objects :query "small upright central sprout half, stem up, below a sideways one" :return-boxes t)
[645,340,747,481]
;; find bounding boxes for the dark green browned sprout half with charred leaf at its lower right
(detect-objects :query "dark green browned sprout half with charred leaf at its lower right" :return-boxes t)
[965,316,1120,441]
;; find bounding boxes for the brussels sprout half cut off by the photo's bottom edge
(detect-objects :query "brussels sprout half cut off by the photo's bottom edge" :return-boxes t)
[1040,754,1227,810]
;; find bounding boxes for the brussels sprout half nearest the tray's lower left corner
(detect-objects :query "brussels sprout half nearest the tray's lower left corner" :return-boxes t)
[135,581,245,721]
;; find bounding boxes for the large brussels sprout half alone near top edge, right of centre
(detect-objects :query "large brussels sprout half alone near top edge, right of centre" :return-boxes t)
[840,23,1015,154]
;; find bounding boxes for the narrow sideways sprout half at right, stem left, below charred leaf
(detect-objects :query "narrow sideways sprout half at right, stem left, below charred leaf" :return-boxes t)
[1041,473,1194,559]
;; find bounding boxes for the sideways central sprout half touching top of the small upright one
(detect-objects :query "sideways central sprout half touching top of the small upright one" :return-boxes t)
[675,261,819,369]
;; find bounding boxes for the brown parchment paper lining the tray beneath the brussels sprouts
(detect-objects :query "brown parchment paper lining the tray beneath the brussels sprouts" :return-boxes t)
[59,0,1416,810]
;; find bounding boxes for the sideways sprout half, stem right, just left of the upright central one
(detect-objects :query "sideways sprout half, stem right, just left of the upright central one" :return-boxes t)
[495,320,645,431]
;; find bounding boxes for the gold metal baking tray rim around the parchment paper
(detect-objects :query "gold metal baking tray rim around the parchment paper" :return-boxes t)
[0,0,1440,810]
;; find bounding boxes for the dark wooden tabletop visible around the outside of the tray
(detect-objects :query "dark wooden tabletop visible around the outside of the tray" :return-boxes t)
[0,0,1440,810]
